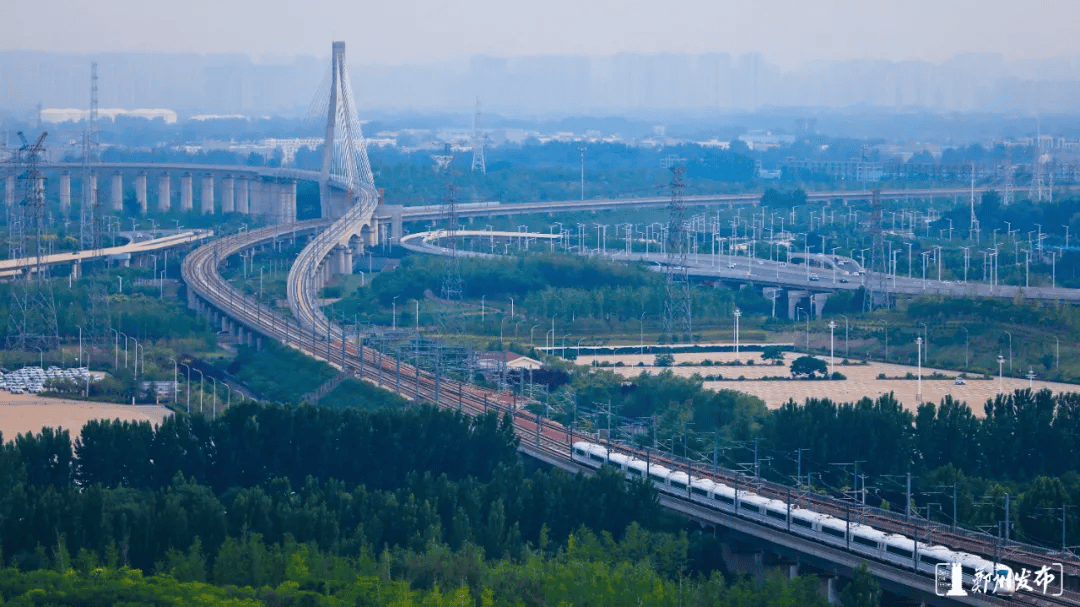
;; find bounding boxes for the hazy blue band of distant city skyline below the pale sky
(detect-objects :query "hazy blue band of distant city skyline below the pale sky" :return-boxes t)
[0,51,1080,119]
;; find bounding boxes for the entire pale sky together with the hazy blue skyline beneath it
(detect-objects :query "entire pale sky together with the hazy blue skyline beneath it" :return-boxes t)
[0,0,1080,114]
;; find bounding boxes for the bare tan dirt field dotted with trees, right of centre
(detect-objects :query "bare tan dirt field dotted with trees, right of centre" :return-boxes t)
[577,352,1080,416]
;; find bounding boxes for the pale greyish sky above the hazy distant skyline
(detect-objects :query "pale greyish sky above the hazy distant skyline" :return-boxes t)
[8,0,1080,68]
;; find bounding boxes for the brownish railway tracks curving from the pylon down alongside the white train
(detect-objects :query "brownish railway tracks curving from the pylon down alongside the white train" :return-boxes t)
[183,219,1080,607]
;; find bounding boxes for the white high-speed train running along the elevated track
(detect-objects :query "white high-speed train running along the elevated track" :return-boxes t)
[572,441,1014,595]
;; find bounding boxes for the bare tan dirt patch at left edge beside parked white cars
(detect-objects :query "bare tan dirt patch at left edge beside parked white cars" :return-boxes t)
[0,392,172,442]
